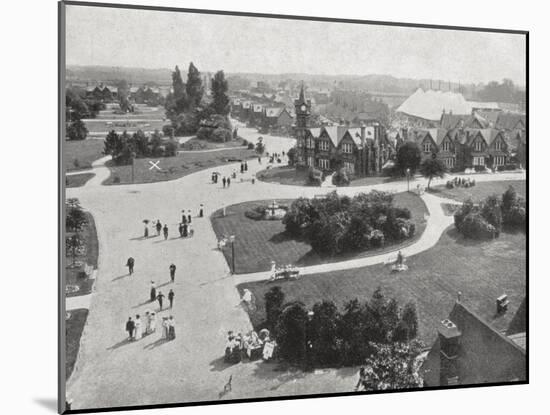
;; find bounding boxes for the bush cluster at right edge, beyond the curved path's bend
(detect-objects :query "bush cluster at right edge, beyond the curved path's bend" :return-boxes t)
[454,186,527,239]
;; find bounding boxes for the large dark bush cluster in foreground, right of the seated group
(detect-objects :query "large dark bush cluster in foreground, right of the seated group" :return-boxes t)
[264,287,418,369]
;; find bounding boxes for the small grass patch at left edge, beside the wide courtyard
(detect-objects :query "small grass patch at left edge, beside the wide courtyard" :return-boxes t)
[65,212,99,297]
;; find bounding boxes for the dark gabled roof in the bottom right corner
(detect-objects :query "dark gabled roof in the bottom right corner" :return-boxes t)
[421,302,526,386]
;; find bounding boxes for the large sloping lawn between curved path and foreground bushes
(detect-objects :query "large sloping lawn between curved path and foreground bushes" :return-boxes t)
[238,227,527,343]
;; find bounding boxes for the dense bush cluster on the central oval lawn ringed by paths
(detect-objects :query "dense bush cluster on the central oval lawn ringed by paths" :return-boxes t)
[283,191,415,255]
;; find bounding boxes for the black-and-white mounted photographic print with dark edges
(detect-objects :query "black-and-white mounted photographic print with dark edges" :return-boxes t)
[59,1,528,412]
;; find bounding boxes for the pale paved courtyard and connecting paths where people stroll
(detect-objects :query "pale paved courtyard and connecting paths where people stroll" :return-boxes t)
[67,127,525,409]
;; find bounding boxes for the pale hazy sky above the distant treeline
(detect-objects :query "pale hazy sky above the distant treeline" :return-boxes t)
[66,5,526,85]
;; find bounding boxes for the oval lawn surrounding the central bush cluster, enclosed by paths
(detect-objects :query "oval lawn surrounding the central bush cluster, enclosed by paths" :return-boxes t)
[211,192,428,274]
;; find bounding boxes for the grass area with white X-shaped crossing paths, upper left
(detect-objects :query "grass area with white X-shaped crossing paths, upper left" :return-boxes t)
[104,147,256,185]
